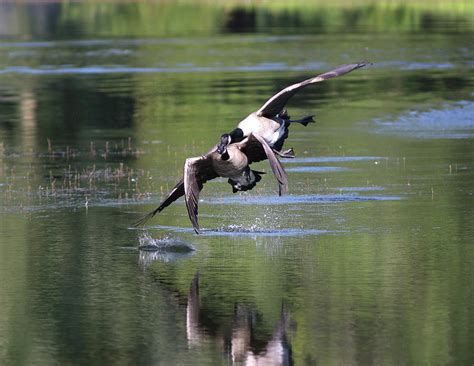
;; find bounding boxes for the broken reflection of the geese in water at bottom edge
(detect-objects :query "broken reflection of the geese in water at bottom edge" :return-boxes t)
[186,273,293,365]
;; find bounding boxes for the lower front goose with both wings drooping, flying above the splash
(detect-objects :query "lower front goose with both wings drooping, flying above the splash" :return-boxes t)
[135,133,288,234]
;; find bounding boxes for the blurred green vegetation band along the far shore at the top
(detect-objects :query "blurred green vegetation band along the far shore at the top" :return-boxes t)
[1,0,474,38]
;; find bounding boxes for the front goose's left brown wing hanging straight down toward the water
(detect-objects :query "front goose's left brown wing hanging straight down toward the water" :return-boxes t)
[184,154,218,234]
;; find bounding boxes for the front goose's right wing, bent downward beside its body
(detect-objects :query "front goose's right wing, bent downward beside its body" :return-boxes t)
[238,133,288,196]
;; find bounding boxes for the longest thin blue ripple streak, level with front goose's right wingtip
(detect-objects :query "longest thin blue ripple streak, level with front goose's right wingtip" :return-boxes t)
[204,193,402,205]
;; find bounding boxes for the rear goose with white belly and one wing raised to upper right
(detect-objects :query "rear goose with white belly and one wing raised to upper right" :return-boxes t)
[217,62,368,157]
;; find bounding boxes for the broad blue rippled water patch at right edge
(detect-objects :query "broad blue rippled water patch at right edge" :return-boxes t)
[375,101,474,139]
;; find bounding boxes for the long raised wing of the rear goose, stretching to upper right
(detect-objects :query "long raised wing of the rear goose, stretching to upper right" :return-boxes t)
[257,62,368,118]
